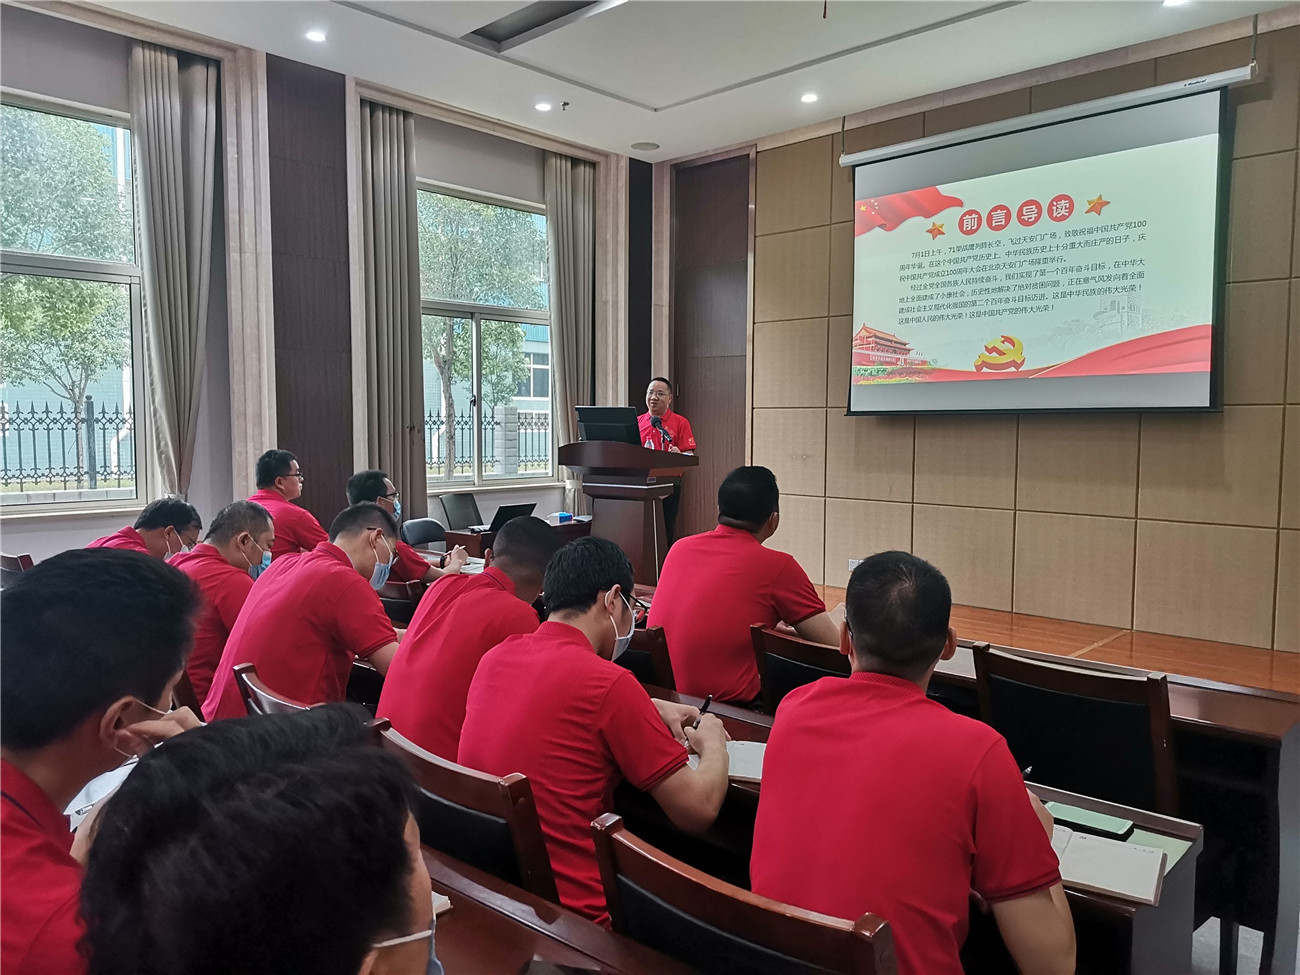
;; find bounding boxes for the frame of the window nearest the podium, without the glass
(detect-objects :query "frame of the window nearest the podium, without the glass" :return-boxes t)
[416,177,563,488]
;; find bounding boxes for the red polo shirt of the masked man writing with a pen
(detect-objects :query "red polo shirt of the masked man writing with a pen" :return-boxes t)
[456,623,686,924]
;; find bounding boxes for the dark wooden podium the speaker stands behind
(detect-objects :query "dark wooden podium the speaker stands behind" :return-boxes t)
[559,441,699,585]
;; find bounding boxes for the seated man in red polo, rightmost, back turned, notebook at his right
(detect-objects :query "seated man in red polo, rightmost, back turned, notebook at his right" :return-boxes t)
[750,551,1074,975]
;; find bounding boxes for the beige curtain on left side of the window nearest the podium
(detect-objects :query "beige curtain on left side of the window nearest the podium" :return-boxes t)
[361,101,429,517]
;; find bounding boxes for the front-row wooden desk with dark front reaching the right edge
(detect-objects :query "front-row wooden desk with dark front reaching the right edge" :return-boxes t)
[930,640,1300,975]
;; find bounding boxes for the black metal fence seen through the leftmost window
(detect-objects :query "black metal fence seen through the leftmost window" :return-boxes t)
[0,397,135,493]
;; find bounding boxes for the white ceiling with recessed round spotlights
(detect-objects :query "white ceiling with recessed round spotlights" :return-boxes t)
[98,0,1294,161]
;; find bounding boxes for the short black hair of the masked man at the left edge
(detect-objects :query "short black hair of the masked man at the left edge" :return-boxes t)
[0,549,199,751]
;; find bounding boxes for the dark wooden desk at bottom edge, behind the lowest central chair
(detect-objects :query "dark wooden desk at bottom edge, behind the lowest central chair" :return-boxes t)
[424,846,694,975]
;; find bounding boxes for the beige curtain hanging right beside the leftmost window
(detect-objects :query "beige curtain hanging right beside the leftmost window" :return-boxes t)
[130,42,220,497]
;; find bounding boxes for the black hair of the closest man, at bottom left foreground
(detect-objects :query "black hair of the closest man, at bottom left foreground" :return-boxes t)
[81,705,413,975]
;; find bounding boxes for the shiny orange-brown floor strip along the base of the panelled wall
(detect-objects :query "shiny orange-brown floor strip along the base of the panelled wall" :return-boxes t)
[819,586,1300,694]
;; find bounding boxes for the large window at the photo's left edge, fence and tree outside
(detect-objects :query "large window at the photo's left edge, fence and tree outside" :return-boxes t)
[0,104,144,506]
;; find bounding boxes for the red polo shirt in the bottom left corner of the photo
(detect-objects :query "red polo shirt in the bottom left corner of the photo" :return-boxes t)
[0,762,86,975]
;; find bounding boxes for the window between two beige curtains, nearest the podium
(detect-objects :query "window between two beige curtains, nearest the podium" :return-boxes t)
[417,189,555,489]
